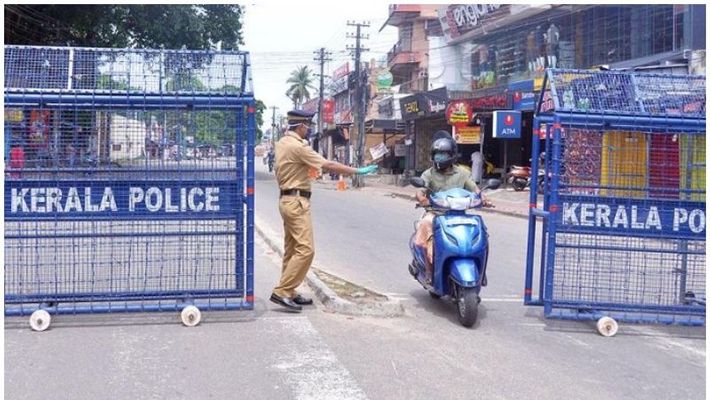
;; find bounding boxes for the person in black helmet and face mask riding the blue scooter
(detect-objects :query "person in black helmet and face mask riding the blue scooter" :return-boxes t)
[414,131,490,283]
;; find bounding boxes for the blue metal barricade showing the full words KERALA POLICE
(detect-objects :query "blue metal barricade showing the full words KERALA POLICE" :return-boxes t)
[4,46,255,322]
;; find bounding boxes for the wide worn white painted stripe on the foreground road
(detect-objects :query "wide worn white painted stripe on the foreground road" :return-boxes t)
[272,318,367,400]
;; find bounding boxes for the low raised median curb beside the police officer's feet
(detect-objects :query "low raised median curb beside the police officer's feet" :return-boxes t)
[254,215,404,317]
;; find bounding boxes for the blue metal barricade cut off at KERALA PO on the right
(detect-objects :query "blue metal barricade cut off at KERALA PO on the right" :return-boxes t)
[525,70,706,325]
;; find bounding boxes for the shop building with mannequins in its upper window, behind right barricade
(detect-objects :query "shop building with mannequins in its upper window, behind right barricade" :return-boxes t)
[438,4,705,178]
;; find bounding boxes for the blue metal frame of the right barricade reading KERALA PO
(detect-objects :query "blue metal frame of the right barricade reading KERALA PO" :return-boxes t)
[524,69,706,334]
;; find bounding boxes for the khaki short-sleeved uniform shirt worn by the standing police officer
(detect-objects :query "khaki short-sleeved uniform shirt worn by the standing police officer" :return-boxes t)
[274,131,328,190]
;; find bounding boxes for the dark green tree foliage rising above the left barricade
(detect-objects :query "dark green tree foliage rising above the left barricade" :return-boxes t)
[5,4,244,50]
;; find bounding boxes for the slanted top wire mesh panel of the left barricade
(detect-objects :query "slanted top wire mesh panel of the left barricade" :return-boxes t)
[5,46,252,95]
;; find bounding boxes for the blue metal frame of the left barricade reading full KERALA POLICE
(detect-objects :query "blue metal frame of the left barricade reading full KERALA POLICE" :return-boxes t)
[4,46,256,320]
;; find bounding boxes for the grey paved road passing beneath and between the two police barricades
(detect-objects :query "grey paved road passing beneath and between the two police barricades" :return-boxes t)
[4,158,706,400]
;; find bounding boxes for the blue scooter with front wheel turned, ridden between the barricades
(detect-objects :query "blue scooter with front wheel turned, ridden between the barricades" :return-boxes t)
[409,177,501,327]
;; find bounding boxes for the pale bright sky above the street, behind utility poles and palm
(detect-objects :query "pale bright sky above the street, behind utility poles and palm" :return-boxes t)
[241,0,397,128]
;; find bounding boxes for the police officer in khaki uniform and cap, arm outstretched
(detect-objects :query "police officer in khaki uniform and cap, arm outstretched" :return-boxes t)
[270,110,377,312]
